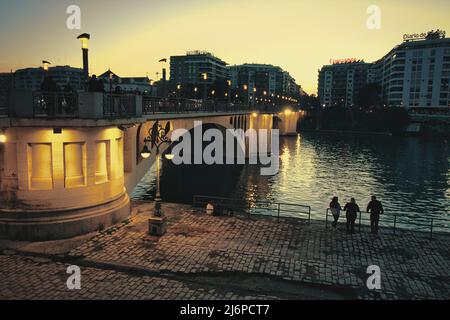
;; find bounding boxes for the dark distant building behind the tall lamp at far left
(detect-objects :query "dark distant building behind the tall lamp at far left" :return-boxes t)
[14,66,83,91]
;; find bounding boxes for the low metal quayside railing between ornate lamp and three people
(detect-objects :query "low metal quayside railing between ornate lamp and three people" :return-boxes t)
[193,195,311,224]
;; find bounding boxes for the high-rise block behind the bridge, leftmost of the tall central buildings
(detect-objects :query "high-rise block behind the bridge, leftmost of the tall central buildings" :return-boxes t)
[170,51,228,85]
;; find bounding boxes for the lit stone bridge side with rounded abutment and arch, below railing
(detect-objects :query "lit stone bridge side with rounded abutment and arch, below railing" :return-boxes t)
[0,112,280,241]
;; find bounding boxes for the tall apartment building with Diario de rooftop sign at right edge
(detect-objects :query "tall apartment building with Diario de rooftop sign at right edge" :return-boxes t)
[376,31,450,108]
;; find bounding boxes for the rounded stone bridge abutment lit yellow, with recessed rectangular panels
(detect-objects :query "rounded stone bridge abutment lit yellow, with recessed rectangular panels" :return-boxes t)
[0,127,130,240]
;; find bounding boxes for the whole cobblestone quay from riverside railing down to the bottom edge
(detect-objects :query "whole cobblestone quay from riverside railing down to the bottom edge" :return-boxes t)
[0,203,450,299]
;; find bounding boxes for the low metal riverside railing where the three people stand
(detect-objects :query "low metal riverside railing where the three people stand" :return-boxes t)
[325,208,450,238]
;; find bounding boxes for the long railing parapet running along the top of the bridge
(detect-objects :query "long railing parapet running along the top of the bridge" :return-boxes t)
[2,90,294,119]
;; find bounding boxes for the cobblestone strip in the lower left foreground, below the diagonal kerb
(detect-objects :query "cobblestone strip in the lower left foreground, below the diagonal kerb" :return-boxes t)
[0,255,277,300]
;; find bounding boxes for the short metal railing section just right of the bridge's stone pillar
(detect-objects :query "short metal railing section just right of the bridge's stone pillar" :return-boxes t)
[103,93,136,118]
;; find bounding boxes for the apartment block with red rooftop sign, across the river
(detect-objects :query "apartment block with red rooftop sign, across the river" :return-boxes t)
[318,59,376,107]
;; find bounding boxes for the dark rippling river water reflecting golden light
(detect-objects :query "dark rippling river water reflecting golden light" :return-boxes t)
[133,133,450,231]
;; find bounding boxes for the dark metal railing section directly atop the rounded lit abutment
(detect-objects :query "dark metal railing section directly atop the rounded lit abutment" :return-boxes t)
[33,92,78,118]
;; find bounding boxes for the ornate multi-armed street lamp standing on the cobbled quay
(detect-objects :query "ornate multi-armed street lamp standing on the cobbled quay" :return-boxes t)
[141,121,174,217]
